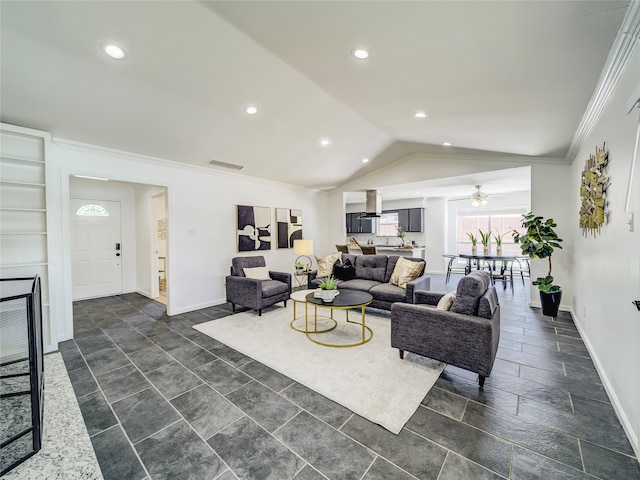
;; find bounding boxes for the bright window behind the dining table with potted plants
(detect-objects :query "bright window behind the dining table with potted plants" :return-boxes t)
[456,209,526,255]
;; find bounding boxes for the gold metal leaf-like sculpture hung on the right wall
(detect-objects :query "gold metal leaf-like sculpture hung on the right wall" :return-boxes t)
[580,143,609,238]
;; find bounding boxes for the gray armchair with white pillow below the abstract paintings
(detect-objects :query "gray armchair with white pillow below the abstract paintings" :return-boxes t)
[225,257,291,316]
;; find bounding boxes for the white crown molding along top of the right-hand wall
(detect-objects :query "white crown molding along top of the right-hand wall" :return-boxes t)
[565,0,640,164]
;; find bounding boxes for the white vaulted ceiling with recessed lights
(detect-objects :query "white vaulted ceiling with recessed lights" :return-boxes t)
[0,0,629,195]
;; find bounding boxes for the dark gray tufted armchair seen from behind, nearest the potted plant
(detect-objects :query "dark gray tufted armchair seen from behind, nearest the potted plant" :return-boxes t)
[391,271,500,388]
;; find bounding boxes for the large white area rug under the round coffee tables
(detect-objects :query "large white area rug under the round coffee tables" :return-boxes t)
[193,302,444,434]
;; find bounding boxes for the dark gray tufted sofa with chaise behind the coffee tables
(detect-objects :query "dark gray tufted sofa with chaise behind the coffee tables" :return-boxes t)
[308,253,431,310]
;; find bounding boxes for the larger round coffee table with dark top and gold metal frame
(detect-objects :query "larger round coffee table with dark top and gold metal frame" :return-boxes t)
[305,290,373,348]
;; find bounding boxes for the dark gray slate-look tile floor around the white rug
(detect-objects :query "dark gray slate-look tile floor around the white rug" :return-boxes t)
[60,276,640,480]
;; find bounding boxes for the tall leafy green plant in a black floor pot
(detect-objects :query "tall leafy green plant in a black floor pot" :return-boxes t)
[513,212,562,318]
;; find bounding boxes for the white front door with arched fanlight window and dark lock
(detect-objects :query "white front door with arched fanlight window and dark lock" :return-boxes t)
[71,198,122,300]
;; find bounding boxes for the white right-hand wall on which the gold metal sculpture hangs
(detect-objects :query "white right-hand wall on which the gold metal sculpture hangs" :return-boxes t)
[569,49,640,452]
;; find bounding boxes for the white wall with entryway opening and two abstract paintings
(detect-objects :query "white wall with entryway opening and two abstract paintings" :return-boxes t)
[47,140,329,341]
